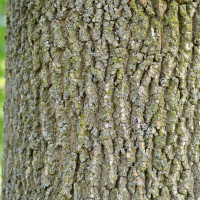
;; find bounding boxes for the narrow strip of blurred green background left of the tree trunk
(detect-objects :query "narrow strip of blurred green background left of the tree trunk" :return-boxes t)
[0,0,6,194]
